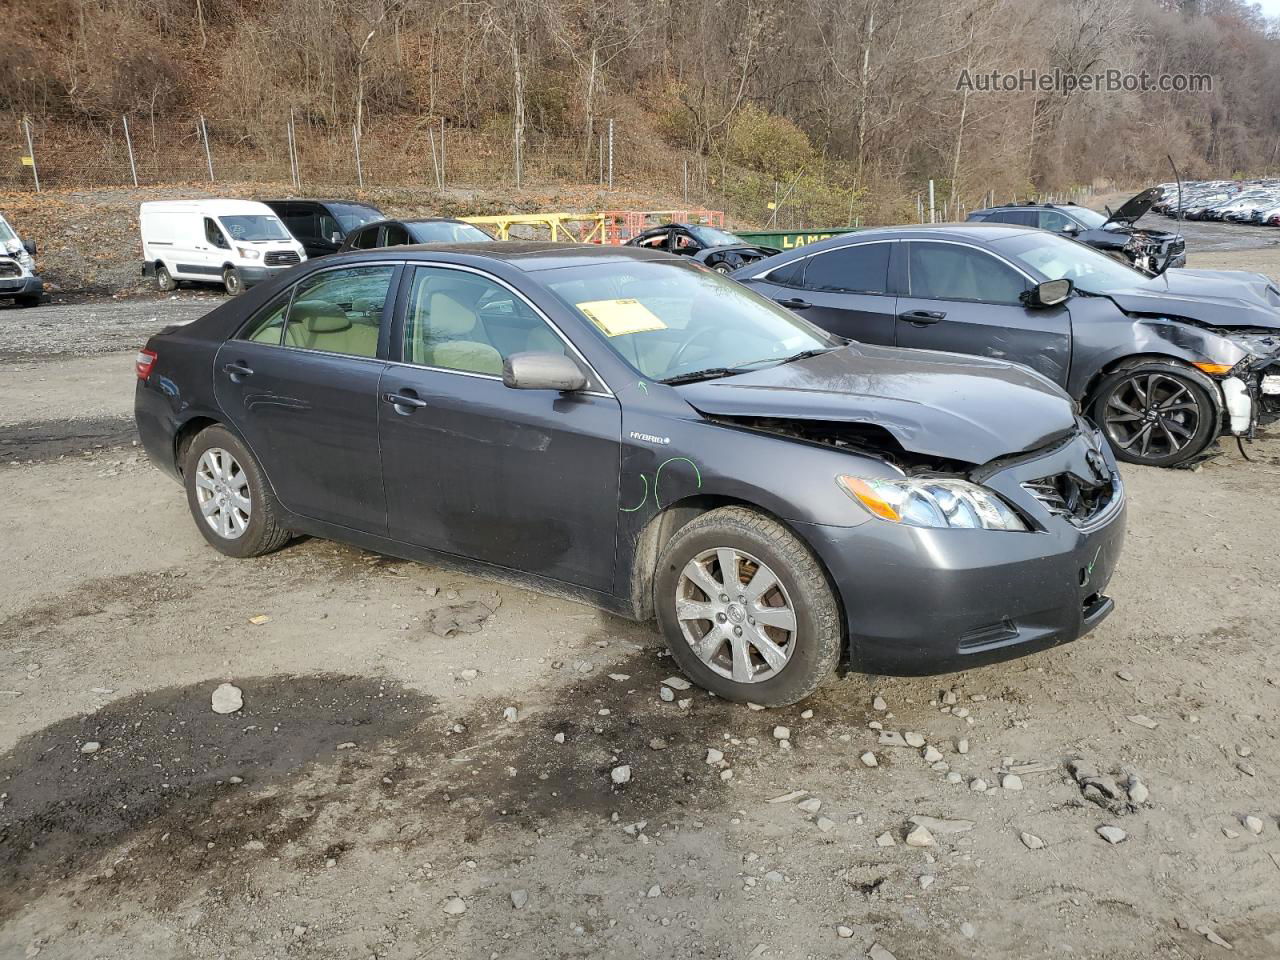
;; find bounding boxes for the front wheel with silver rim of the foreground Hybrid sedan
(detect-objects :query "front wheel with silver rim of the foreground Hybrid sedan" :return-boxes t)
[654,507,842,707]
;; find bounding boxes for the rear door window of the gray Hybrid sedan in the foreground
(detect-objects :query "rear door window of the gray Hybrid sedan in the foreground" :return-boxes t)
[284,265,396,357]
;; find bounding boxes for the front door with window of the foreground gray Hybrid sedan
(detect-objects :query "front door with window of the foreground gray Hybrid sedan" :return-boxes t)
[378,266,622,590]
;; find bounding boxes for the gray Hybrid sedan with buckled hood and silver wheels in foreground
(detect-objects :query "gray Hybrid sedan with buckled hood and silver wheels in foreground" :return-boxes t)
[136,243,1125,705]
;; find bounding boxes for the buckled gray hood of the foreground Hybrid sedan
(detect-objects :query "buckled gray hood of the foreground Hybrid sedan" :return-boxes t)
[676,344,1075,463]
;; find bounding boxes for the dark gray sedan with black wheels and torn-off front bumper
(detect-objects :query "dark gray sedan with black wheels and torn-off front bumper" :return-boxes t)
[735,224,1280,467]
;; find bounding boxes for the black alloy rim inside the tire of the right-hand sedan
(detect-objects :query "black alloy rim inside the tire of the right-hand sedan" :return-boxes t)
[1103,372,1203,460]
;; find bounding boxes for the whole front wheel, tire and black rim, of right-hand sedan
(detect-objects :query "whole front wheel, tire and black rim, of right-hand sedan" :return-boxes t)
[1093,362,1219,467]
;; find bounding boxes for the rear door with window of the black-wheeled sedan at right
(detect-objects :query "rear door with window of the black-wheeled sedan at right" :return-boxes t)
[753,241,895,344]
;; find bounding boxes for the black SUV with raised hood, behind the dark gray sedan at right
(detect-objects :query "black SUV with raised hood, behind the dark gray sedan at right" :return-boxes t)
[969,187,1187,274]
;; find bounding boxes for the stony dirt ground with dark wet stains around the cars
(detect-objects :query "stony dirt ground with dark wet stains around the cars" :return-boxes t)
[0,235,1280,960]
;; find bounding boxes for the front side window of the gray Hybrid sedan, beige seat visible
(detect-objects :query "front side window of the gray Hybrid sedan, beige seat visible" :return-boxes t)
[403,266,564,376]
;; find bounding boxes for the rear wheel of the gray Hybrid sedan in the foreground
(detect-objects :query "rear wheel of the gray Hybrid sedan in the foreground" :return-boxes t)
[183,426,289,557]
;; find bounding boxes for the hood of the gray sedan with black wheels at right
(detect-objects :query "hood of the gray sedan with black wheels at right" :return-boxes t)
[1107,269,1280,330]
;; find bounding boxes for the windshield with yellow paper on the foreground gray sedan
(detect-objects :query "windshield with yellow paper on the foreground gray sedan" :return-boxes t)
[539,261,844,380]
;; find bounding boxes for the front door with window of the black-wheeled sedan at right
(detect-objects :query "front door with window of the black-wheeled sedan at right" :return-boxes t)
[897,241,1071,387]
